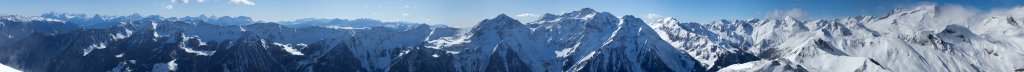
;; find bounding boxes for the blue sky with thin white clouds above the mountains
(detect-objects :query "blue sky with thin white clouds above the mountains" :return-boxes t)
[0,0,1024,27]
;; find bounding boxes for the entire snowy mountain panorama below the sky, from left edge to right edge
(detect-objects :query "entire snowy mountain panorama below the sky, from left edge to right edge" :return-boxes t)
[0,5,1024,72]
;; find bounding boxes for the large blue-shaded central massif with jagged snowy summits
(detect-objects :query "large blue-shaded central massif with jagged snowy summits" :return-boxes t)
[411,8,703,72]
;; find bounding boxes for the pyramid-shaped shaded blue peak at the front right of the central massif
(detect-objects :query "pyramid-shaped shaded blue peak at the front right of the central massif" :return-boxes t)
[568,15,702,72]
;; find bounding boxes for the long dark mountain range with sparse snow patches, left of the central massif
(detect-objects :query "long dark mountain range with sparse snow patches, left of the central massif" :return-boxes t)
[0,13,460,71]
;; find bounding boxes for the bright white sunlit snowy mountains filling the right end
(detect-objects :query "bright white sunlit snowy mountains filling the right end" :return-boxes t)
[712,5,1024,72]
